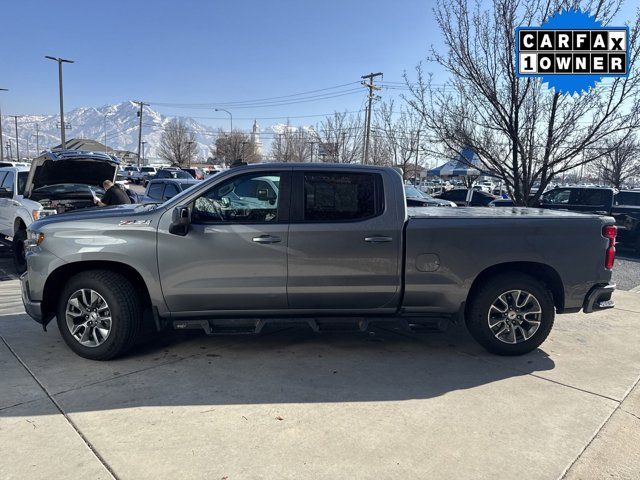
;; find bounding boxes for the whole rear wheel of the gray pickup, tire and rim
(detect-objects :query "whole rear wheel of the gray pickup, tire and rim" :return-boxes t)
[466,273,555,355]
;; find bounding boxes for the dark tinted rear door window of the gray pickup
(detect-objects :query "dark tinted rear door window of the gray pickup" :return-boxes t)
[303,172,384,222]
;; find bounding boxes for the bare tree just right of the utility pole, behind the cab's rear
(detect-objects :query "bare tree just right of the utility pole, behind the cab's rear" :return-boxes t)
[376,100,423,180]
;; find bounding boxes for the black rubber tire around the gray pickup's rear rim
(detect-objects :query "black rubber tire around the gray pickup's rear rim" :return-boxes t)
[465,272,555,355]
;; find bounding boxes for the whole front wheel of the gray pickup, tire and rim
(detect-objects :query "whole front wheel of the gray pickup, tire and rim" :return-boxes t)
[57,270,142,360]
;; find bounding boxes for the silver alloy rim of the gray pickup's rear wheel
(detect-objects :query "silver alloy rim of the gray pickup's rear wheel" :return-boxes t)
[487,290,542,344]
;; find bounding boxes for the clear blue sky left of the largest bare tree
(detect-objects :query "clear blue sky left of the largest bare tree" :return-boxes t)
[0,0,437,126]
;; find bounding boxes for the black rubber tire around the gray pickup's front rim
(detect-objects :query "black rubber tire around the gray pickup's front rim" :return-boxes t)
[56,270,142,360]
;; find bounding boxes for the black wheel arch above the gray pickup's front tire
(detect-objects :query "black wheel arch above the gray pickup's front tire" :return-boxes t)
[42,260,152,316]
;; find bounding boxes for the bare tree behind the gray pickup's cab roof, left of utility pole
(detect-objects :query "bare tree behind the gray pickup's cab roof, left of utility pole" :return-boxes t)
[315,112,364,163]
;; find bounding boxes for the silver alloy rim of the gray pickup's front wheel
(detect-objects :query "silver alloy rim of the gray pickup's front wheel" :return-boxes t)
[65,288,112,347]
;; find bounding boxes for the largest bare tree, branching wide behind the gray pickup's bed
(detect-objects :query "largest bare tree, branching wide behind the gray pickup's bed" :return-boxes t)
[405,0,640,205]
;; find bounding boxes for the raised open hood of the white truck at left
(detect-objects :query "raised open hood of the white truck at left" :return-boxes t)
[24,155,118,198]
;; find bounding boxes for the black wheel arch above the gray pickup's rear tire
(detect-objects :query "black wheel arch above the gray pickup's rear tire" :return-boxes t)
[467,262,565,312]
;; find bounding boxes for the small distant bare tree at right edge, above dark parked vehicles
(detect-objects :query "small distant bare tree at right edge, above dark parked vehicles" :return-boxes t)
[596,136,640,188]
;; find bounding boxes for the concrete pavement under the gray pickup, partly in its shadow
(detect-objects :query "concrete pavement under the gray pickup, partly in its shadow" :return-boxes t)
[0,282,640,480]
